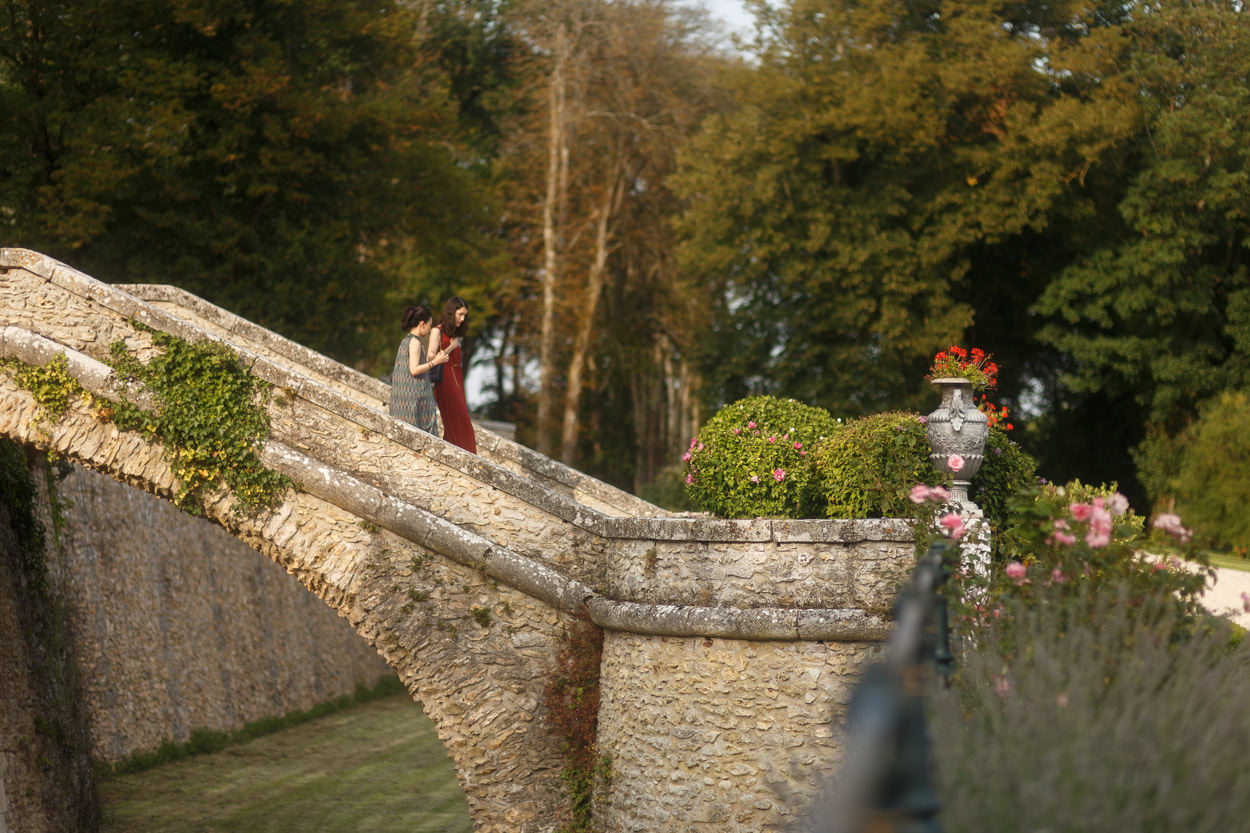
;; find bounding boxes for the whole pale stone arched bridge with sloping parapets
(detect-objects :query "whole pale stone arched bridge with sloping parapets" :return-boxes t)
[0,249,914,833]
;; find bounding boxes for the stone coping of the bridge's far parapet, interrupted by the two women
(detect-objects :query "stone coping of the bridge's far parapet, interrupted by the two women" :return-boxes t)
[113,284,669,515]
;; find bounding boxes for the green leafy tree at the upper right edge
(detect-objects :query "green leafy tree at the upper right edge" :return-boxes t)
[1036,4,1250,433]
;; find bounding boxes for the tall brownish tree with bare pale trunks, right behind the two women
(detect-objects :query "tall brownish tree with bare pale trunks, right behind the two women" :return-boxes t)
[495,0,730,468]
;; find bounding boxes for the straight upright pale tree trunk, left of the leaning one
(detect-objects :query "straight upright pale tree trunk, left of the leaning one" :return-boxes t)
[538,24,570,455]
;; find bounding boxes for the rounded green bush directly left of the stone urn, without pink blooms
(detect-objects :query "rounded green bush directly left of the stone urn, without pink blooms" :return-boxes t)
[815,411,943,518]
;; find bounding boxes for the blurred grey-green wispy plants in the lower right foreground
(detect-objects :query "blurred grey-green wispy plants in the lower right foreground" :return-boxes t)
[929,583,1250,833]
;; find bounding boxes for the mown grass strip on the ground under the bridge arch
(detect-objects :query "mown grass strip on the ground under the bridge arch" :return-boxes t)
[100,694,473,833]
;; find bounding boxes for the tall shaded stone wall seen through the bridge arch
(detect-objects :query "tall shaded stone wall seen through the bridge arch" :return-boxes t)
[56,467,390,760]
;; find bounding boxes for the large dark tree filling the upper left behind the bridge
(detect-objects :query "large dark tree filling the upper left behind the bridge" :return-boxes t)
[0,0,489,361]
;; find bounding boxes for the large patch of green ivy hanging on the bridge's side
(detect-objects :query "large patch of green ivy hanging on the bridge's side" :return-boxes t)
[111,324,291,514]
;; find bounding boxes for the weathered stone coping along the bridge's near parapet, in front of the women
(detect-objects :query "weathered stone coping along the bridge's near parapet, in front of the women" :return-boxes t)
[0,249,913,543]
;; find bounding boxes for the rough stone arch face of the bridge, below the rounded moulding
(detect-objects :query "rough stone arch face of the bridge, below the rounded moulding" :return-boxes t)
[0,380,566,830]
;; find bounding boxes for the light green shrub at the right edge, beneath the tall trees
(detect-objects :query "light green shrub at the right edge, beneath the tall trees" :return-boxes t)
[1138,390,1250,549]
